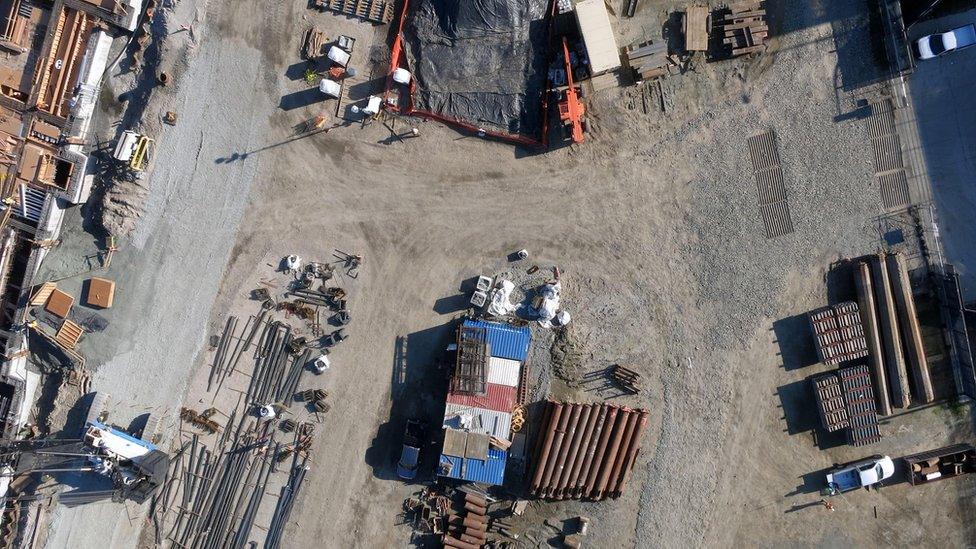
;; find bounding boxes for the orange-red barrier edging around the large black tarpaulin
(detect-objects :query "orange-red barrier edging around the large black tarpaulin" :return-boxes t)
[383,0,556,148]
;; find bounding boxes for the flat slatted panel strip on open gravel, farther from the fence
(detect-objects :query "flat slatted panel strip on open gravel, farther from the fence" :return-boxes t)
[748,130,793,238]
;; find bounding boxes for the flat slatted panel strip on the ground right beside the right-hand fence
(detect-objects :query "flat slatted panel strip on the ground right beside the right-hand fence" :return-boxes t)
[867,99,911,210]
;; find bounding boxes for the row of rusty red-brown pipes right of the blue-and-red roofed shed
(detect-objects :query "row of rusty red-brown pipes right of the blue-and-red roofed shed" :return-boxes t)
[529,401,649,500]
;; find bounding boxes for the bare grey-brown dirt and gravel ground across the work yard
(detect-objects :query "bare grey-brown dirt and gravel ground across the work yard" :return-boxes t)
[26,0,976,547]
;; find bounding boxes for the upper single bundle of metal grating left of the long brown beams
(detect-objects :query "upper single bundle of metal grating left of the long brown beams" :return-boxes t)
[809,301,868,364]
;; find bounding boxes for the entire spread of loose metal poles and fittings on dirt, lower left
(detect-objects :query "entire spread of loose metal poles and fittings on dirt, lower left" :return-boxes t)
[145,254,362,548]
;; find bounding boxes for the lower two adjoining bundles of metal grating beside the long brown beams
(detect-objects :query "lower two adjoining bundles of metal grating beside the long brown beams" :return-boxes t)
[811,364,881,446]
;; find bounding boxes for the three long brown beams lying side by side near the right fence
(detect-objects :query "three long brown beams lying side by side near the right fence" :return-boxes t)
[854,253,935,408]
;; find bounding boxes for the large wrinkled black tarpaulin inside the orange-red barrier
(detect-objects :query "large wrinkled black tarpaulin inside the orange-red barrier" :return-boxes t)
[403,0,548,137]
